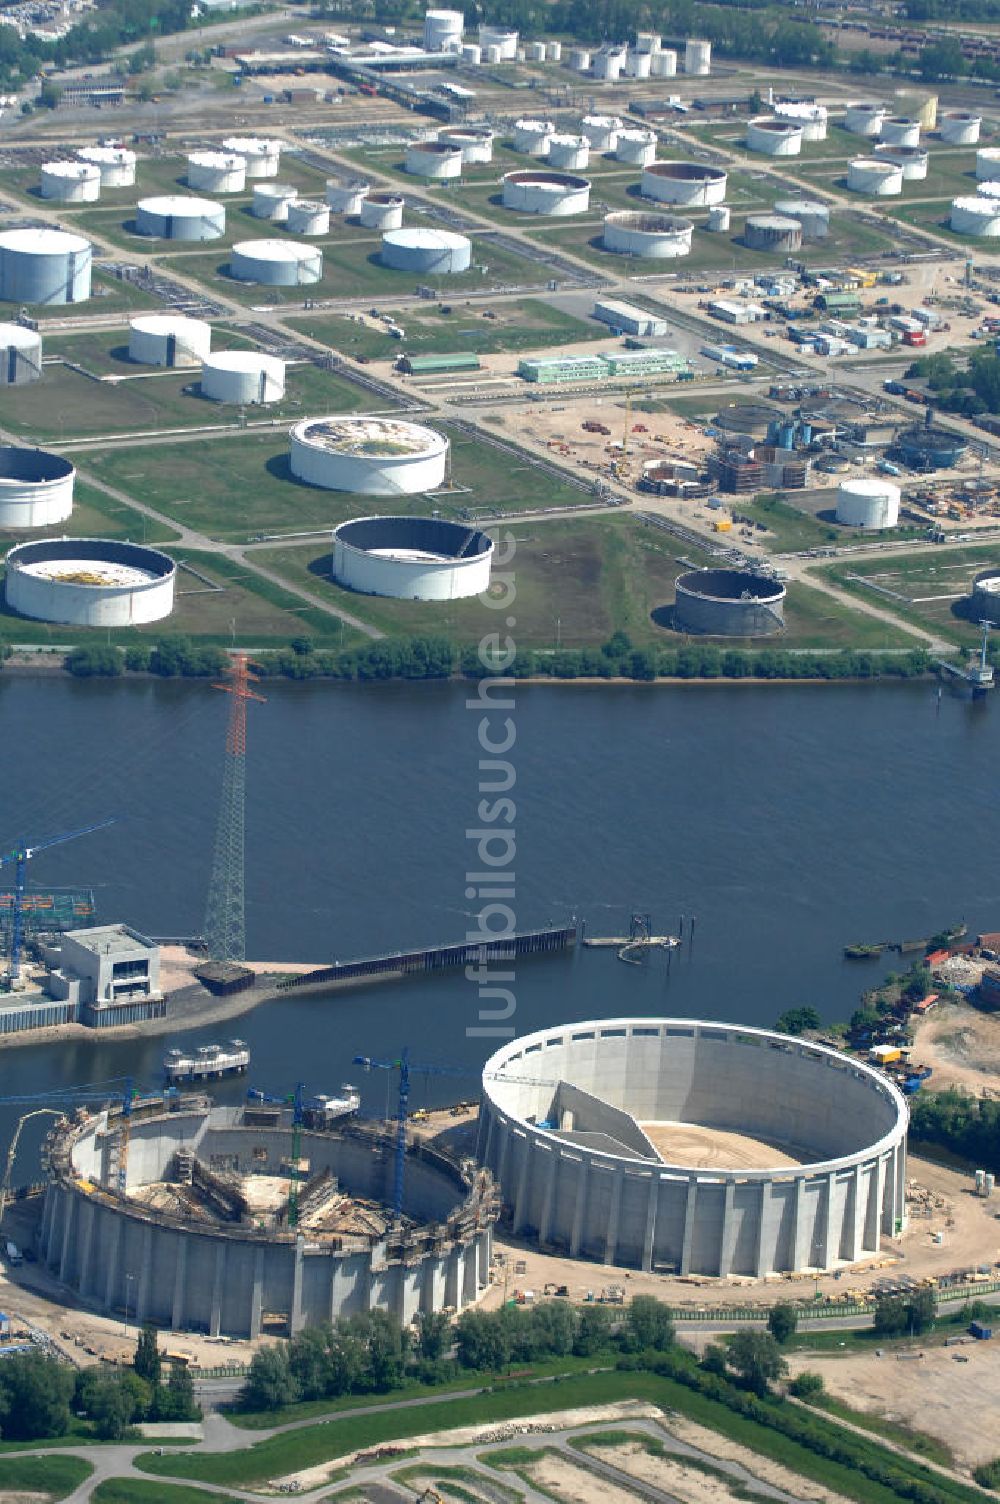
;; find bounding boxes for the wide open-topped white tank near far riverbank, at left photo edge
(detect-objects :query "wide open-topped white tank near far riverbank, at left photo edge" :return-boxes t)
[6,538,177,627]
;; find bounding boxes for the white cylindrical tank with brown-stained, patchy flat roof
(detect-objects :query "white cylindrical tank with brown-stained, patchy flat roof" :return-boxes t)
[290,417,448,496]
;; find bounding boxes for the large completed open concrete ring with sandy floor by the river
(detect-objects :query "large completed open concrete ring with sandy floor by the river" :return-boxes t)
[478,1018,908,1278]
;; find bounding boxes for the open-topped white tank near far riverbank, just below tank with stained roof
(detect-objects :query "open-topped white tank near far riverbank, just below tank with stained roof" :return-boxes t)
[334,517,493,600]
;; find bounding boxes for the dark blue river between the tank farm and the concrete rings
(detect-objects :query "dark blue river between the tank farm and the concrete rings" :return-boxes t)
[0,677,1000,1161]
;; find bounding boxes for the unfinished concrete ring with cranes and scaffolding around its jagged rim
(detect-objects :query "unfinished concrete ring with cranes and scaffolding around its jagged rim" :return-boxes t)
[41,1096,496,1337]
